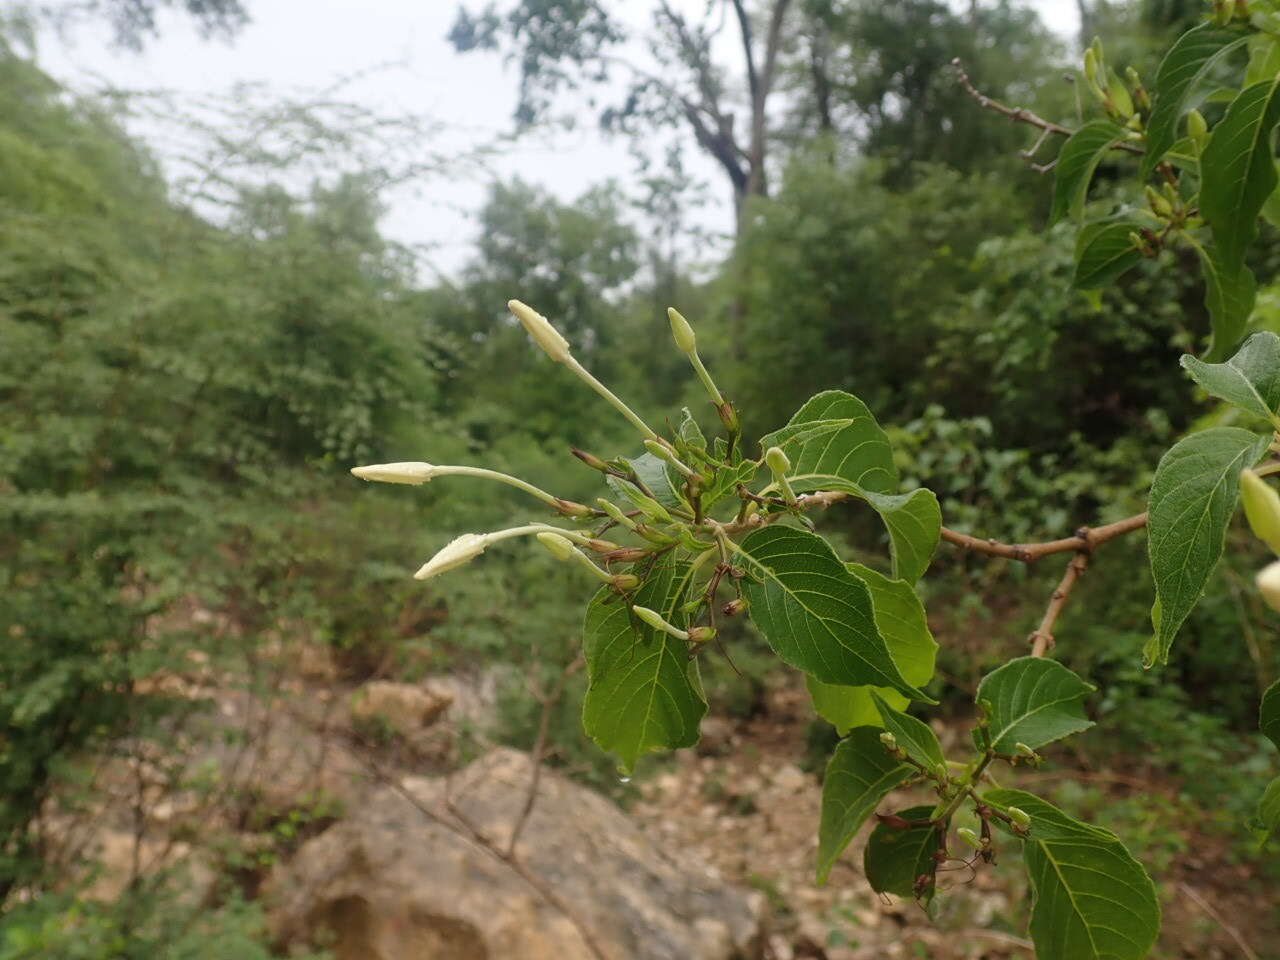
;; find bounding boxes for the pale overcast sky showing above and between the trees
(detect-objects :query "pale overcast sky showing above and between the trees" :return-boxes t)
[30,0,1078,271]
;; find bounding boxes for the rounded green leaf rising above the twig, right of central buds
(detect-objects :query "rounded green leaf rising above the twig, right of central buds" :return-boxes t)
[760,390,897,493]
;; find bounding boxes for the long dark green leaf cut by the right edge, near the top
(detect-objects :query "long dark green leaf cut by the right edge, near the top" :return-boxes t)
[1199,76,1280,275]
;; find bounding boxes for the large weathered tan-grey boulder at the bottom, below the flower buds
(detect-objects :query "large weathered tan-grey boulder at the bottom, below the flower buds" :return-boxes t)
[269,750,764,960]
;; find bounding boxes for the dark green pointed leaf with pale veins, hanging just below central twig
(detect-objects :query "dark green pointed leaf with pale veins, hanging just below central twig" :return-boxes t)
[739,526,933,703]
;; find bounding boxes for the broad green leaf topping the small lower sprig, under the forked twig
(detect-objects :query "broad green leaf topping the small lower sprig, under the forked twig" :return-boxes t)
[975,657,1094,754]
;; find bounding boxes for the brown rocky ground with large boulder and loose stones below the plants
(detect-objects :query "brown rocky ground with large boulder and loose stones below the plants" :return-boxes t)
[67,640,1280,960]
